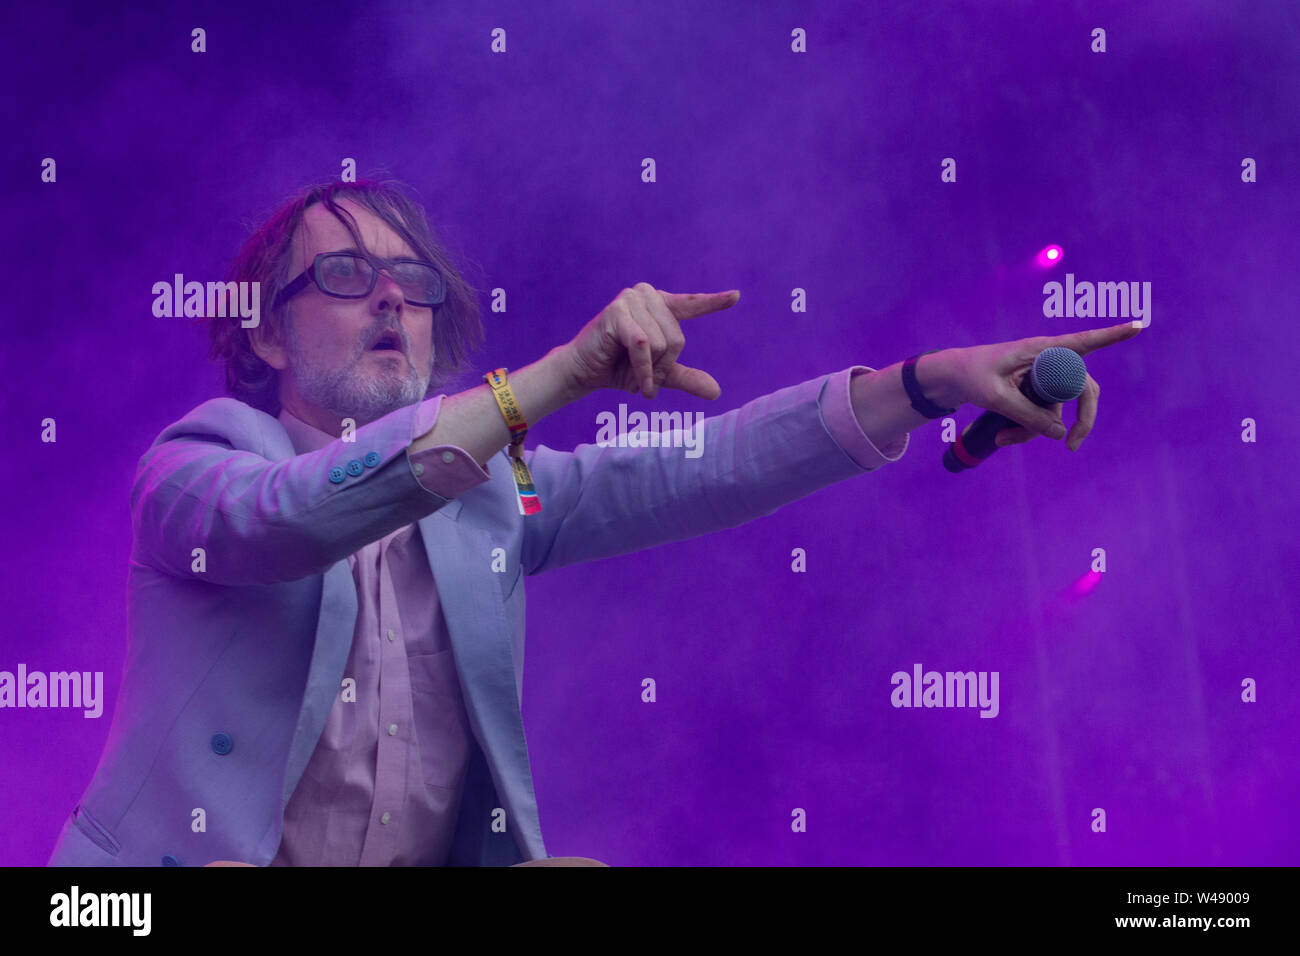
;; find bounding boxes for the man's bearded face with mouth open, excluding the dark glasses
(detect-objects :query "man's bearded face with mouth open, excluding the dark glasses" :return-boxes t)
[254,199,433,434]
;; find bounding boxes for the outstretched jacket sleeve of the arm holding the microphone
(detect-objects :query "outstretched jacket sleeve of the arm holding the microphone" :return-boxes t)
[521,365,909,575]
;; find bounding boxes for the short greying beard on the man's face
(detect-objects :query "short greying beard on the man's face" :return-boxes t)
[285,314,433,425]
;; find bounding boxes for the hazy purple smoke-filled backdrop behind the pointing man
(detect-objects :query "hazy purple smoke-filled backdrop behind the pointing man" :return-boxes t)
[0,0,1300,865]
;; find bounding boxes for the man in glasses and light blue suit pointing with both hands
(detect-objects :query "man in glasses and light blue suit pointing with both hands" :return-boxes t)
[49,182,1136,866]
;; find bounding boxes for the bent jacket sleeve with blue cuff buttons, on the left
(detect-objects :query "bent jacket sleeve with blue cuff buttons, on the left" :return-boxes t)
[131,397,488,585]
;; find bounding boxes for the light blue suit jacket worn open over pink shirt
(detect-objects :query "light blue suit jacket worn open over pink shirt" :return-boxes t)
[49,376,894,866]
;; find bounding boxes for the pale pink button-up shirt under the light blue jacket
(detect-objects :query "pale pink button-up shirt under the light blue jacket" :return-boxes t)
[270,365,909,866]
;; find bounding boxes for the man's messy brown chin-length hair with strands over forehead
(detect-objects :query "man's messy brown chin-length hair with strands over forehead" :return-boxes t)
[208,179,484,415]
